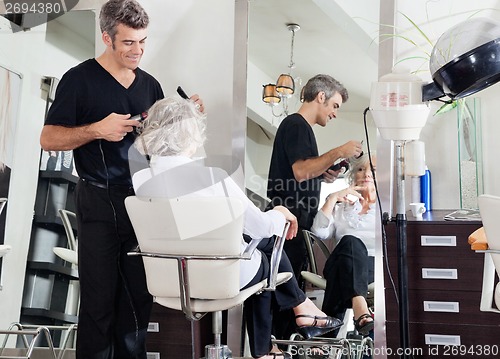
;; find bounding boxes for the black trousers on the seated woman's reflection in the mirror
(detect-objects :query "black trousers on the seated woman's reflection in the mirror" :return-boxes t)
[322,235,374,318]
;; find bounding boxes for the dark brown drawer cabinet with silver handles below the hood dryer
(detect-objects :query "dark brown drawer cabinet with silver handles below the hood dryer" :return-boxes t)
[384,210,500,358]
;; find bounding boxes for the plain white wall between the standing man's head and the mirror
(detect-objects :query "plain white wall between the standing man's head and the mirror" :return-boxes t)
[141,0,246,160]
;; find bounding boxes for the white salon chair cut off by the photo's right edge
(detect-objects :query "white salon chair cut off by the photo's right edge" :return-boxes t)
[477,194,500,313]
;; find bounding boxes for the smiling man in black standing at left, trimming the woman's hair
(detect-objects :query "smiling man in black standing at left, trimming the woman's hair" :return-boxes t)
[40,0,203,359]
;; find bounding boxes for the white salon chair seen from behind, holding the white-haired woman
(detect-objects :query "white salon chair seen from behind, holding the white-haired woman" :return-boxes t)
[125,196,292,359]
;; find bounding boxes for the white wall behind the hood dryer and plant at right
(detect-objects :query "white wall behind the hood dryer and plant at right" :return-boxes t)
[386,0,500,209]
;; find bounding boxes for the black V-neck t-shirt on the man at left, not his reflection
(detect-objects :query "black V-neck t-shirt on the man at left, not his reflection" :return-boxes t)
[45,59,164,186]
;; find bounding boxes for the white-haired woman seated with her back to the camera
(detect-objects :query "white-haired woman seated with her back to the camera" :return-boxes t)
[132,97,342,359]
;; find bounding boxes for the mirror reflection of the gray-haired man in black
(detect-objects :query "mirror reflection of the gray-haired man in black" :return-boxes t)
[267,74,362,338]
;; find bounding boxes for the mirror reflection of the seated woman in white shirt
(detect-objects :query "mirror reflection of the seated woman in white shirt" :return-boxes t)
[311,154,377,335]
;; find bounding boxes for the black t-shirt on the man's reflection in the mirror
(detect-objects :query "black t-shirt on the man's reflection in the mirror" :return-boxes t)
[267,113,321,228]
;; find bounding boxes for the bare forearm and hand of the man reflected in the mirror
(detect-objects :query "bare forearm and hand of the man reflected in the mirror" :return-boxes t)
[292,141,362,182]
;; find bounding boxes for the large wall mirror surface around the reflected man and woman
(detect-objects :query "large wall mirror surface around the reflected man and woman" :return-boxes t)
[245,0,383,348]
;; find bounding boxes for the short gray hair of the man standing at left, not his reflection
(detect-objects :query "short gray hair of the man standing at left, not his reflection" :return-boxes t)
[99,0,149,41]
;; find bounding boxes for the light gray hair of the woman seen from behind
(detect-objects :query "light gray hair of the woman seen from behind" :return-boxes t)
[134,97,206,156]
